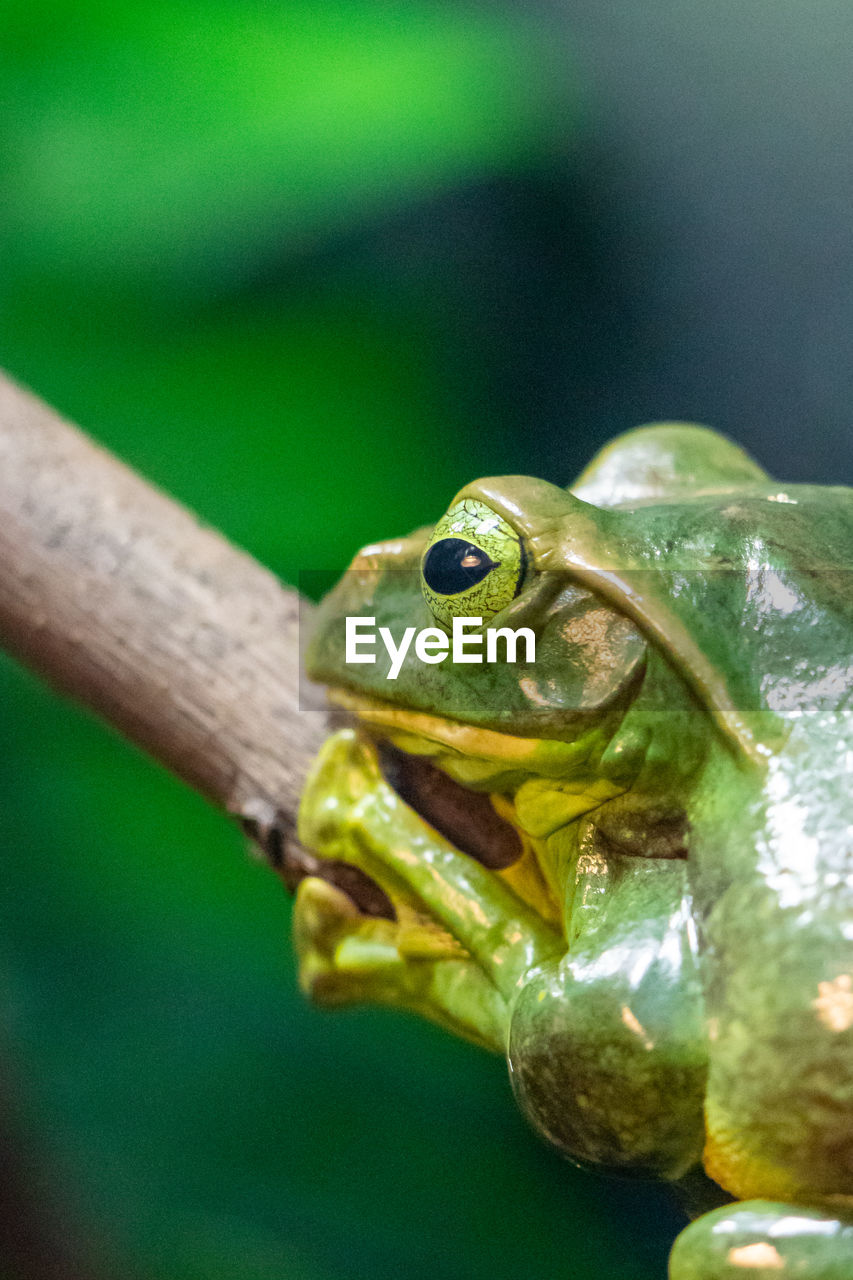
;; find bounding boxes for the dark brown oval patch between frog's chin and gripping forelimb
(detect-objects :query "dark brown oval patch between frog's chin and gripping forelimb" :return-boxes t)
[379,742,524,870]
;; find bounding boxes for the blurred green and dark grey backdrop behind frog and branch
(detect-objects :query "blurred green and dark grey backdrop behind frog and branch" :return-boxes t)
[0,0,853,1280]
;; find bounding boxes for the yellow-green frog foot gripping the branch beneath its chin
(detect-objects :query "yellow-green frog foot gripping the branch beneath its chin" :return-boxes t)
[289,730,560,1050]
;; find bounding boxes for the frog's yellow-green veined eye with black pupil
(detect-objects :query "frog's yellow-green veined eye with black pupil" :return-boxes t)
[420,498,524,626]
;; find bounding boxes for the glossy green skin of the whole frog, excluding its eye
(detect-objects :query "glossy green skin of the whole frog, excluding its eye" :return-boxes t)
[295,425,853,1280]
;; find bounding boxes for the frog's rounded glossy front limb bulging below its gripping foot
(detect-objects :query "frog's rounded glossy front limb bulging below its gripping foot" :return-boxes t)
[510,856,706,1179]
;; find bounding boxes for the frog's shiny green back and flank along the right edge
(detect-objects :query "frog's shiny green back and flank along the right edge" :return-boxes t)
[573,424,853,1201]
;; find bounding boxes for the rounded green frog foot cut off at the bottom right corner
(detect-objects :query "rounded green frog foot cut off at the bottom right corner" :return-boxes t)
[670,1201,853,1280]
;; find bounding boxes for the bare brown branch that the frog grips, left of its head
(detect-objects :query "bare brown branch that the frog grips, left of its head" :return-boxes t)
[0,375,324,851]
